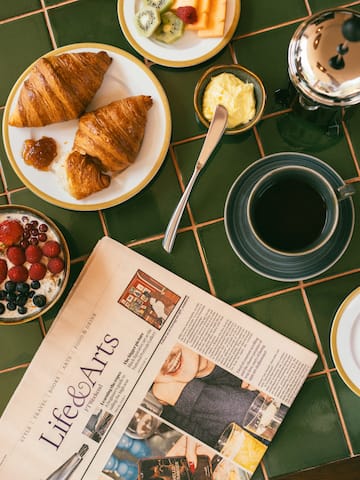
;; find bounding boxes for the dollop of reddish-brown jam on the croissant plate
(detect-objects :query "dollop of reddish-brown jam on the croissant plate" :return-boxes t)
[23,137,57,170]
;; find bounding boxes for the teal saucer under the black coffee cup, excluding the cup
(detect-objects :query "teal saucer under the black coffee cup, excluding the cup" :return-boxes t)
[224,152,355,282]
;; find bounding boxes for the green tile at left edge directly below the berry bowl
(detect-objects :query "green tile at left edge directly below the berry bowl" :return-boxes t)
[0,320,43,370]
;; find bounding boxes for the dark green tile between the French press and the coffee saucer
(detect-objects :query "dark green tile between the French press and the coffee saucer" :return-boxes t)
[258,114,356,180]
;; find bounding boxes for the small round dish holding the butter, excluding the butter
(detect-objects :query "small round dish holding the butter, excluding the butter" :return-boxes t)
[193,64,266,135]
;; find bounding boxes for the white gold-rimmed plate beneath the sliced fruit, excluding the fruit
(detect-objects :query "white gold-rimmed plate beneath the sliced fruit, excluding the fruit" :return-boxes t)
[118,0,240,67]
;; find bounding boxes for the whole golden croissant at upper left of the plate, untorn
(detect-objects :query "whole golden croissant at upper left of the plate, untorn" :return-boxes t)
[9,51,112,127]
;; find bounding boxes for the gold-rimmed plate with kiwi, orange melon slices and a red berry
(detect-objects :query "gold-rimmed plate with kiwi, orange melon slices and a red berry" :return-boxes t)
[118,0,240,67]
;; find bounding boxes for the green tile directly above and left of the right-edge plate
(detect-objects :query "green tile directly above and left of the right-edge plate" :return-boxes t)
[306,273,360,367]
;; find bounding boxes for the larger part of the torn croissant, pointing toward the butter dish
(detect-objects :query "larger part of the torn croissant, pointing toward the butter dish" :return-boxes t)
[73,95,153,172]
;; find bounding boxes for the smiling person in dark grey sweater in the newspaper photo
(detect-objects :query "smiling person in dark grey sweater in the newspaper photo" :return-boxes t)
[151,343,288,448]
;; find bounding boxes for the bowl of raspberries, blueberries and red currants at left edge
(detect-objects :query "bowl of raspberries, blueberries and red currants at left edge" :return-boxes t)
[0,205,70,325]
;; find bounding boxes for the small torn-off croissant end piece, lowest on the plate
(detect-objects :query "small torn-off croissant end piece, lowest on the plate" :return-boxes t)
[65,151,110,200]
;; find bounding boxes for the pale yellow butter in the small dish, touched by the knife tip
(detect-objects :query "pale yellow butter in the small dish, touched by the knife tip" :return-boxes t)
[202,73,256,128]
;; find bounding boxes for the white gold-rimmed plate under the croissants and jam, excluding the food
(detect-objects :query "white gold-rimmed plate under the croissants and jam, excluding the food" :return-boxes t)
[3,43,171,211]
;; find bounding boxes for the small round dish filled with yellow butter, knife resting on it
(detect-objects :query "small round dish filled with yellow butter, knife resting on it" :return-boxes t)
[194,64,266,135]
